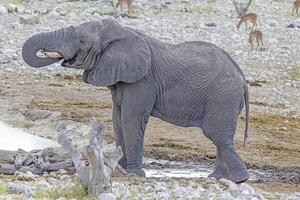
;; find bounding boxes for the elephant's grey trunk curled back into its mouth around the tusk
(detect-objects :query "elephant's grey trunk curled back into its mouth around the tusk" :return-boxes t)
[22,30,62,67]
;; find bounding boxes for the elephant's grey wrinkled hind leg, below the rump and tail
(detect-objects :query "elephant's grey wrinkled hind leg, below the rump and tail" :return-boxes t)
[202,94,249,183]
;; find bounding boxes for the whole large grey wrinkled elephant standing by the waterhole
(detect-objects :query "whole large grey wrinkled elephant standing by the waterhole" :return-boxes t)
[22,19,249,182]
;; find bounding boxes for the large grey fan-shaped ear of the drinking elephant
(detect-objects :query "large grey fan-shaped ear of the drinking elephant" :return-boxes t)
[83,20,151,86]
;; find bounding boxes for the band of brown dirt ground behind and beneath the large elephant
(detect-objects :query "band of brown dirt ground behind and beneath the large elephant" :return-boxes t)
[0,74,300,192]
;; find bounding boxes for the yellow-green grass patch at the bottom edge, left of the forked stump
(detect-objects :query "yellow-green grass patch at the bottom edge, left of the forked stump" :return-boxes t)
[35,179,96,200]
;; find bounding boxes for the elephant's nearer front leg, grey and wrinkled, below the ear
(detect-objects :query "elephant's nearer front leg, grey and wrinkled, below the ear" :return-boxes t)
[119,80,156,176]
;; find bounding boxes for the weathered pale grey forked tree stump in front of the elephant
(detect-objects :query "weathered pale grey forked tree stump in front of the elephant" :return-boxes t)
[57,118,123,197]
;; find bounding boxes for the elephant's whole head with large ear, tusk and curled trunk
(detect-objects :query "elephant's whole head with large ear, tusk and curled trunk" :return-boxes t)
[22,19,151,86]
